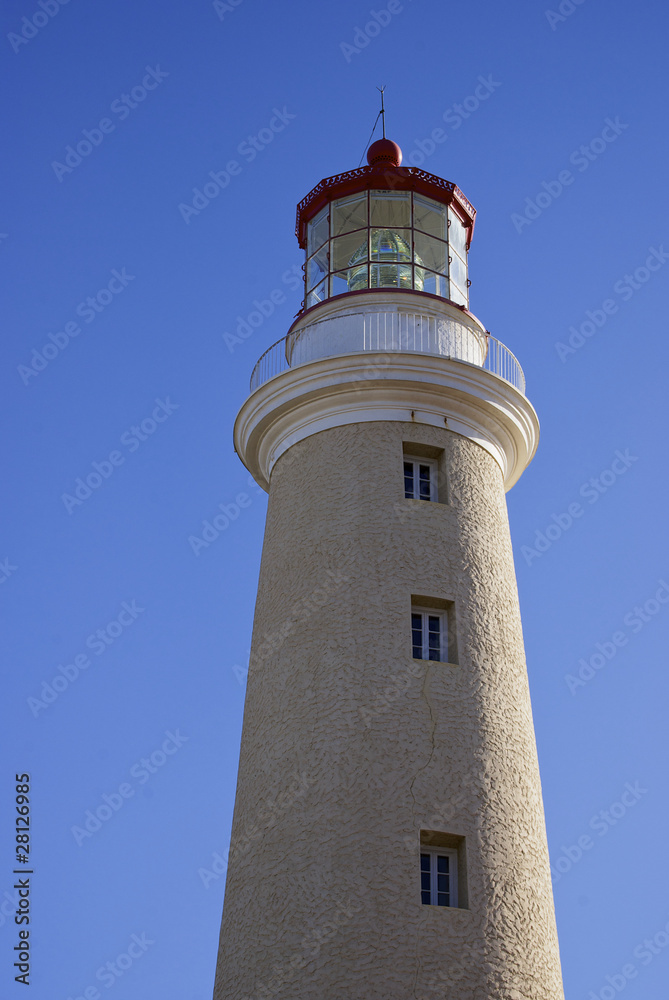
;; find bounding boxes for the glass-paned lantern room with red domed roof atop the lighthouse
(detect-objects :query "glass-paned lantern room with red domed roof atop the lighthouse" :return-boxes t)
[296,139,476,309]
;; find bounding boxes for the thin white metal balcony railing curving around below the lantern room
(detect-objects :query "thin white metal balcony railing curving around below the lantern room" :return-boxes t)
[251,312,525,394]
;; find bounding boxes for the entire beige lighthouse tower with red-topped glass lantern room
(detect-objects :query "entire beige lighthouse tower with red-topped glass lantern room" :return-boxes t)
[214,138,563,1000]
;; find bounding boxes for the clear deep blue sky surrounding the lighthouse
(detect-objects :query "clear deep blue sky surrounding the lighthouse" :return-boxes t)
[0,0,669,1000]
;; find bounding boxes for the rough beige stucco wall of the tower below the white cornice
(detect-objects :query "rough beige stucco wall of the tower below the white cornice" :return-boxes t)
[214,422,563,1000]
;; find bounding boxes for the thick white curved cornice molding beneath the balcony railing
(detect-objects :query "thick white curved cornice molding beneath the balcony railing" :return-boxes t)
[234,351,539,490]
